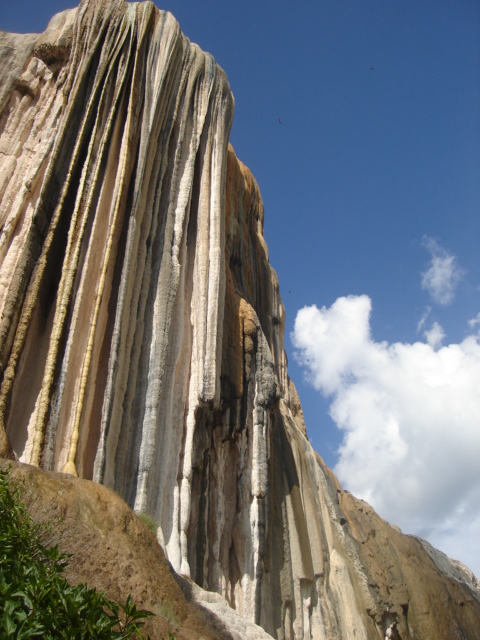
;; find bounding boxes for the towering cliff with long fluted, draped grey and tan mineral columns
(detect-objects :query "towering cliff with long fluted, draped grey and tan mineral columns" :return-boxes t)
[0,0,480,639]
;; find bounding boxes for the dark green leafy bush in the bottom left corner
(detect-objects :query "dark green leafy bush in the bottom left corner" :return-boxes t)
[0,470,153,640]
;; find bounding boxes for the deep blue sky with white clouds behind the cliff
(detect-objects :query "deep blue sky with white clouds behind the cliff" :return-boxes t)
[0,0,480,576]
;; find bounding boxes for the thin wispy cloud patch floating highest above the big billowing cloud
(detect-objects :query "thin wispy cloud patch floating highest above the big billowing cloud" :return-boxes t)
[422,237,465,305]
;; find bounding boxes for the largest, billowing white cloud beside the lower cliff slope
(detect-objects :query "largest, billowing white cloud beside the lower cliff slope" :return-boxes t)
[292,295,480,574]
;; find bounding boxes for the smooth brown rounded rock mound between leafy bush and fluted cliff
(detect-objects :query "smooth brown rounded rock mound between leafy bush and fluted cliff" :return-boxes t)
[0,459,270,640]
